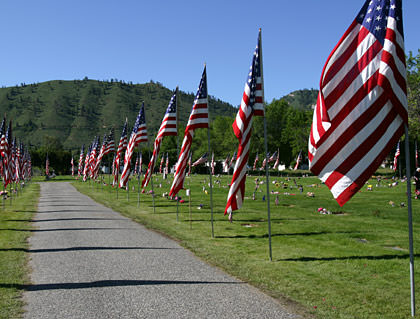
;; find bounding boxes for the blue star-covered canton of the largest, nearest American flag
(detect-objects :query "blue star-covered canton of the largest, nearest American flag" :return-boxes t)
[356,0,403,45]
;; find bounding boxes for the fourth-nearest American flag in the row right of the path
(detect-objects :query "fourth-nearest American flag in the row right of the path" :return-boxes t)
[141,88,178,188]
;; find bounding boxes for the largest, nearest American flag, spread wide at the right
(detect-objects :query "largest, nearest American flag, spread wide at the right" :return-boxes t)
[308,0,408,206]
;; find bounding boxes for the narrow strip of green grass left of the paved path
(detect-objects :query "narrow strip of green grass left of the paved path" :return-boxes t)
[0,183,39,318]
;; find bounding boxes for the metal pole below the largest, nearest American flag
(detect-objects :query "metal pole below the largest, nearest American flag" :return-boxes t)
[405,124,416,317]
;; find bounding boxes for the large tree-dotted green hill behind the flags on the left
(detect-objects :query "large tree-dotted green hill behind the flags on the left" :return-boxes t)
[0,78,236,149]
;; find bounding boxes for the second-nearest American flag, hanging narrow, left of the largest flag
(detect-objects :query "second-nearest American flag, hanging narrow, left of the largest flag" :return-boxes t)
[225,29,264,220]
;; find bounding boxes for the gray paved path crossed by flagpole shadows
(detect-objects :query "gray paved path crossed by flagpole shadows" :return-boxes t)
[24,182,296,318]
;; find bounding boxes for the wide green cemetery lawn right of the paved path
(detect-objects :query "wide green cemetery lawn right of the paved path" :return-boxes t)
[74,176,420,319]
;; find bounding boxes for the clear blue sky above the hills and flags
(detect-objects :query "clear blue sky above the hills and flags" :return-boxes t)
[0,0,420,105]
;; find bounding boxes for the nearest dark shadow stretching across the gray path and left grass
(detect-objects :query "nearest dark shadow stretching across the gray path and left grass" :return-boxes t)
[0,280,243,291]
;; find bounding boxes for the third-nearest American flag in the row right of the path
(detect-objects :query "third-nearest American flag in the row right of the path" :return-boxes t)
[169,67,209,196]
